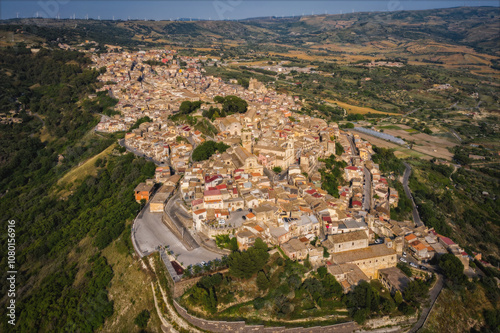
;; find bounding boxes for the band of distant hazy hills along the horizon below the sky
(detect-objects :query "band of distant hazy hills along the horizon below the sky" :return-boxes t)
[0,7,500,56]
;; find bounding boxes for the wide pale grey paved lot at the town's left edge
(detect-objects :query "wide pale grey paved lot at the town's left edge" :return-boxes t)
[134,204,221,267]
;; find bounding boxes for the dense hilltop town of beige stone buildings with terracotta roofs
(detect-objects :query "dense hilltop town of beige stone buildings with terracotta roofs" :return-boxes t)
[93,50,469,292]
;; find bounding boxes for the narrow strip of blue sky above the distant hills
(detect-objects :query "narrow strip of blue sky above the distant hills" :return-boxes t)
[0,0,499,20]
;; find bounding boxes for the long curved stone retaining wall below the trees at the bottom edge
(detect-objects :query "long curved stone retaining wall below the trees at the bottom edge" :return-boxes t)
[174,301,359,333]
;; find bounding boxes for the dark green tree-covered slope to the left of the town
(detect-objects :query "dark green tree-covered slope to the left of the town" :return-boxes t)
[0,45,154,332]
